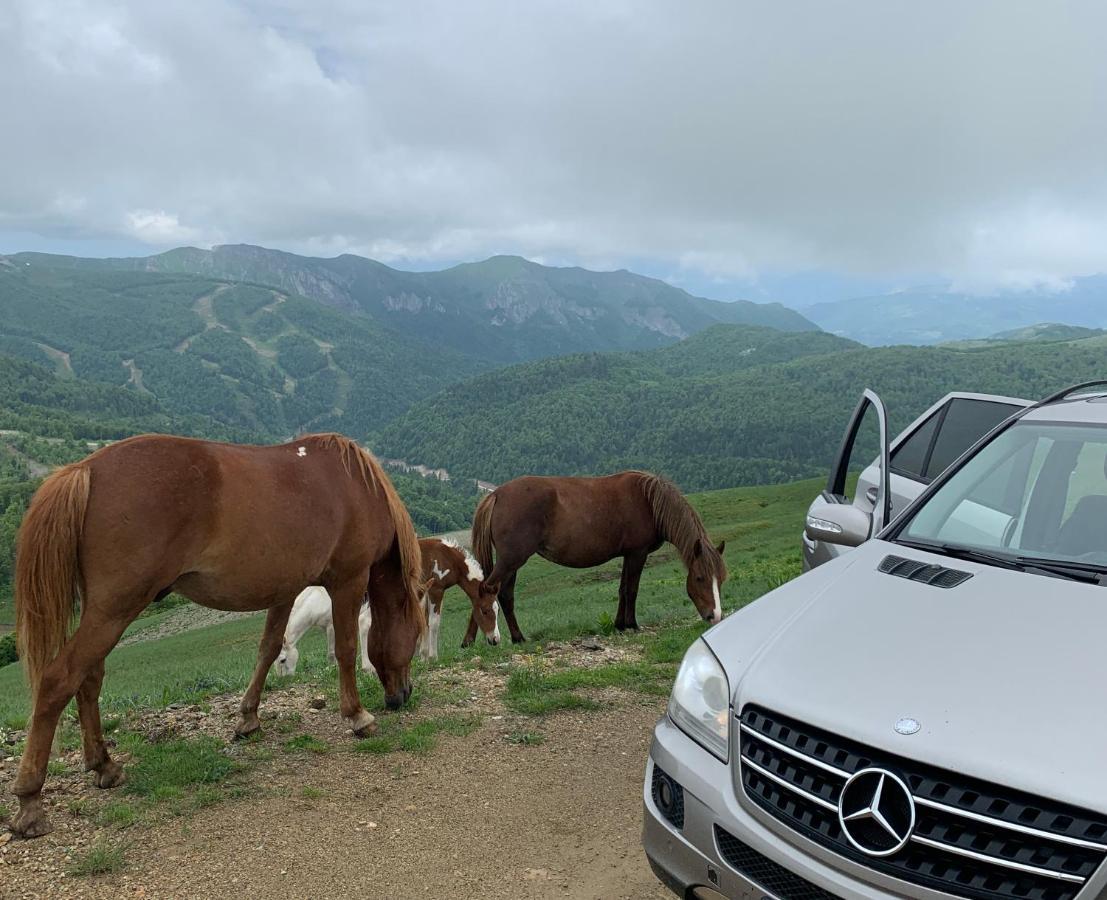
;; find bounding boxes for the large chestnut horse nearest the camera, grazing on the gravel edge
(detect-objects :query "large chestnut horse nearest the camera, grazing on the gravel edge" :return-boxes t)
[12,434,425,837]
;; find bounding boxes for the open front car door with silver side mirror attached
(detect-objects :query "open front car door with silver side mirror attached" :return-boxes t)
[804,390,891,571]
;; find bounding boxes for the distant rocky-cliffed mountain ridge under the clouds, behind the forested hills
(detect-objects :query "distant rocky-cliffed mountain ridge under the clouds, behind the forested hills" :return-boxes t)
[11,245,817,363]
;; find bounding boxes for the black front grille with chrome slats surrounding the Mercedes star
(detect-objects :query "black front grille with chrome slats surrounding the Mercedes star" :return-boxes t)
[736,706,1107,900]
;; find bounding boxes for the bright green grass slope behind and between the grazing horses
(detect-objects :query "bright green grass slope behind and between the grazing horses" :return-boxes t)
[0,473,820,726]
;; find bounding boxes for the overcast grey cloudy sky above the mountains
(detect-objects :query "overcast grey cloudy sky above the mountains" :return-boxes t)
[0,0,1107,296]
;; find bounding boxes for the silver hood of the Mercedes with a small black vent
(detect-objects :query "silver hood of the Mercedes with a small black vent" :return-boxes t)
[705,540,1107,813]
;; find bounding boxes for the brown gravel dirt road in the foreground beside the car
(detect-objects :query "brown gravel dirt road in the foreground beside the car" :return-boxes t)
[0,697,669,900]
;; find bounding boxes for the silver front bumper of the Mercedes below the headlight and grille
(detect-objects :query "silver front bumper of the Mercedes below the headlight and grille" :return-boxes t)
[642,716,916,900]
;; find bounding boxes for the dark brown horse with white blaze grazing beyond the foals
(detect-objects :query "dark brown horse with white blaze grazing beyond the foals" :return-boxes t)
[463,472,726,646]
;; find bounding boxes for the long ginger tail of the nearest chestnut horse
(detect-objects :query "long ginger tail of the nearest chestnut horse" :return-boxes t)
[15,463,91,697]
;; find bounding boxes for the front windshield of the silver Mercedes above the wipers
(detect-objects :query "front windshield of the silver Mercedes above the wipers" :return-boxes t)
[897,420,1107,569]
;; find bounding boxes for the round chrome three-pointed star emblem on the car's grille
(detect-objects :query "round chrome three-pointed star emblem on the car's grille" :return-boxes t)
[838,768,914,856]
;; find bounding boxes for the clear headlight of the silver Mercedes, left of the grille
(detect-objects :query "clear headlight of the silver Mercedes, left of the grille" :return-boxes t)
[669,639,731,763]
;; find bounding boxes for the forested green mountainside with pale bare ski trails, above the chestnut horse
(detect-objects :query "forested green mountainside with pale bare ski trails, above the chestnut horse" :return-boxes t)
[0,257,484,437]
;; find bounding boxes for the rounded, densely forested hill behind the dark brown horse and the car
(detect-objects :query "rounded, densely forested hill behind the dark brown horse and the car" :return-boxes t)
[374,331,1107,489]
